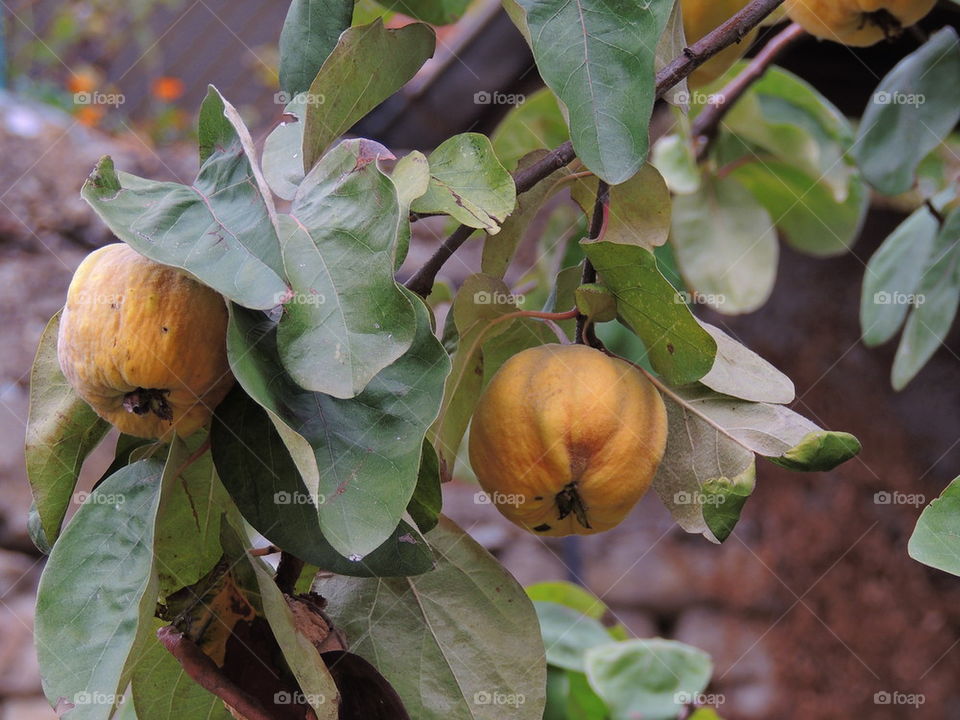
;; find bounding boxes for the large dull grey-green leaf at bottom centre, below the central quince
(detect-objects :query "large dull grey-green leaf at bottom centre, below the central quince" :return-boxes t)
[316,518,546,720]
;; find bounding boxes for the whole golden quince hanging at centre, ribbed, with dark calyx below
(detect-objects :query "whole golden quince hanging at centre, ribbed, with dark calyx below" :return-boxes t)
[470,345,667,536]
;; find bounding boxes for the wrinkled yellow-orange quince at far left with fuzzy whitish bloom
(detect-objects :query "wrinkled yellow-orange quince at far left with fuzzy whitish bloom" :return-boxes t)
[57,243,233,439]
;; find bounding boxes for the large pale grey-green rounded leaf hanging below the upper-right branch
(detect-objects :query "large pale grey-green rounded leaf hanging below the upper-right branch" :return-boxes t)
[670,177,780,315]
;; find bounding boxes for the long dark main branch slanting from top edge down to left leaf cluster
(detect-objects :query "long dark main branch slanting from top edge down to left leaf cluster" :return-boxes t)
[406,0,785,297]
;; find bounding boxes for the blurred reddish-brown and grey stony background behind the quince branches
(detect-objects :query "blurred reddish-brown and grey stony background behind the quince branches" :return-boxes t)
[0,91,960,720]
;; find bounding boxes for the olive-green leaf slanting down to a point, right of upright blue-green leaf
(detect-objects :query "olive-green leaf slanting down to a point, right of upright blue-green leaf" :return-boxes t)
[303,18,436,170]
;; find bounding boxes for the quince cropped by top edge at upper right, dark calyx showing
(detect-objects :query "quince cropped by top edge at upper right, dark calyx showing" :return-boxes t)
[785,0,936,47]
